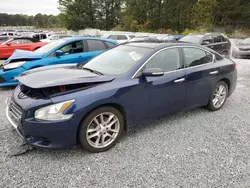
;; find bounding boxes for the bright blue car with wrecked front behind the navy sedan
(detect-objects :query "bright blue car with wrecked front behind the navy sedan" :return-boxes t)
[0,37,117,87]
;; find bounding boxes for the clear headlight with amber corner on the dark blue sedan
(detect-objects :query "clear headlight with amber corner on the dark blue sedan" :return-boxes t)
[35,100,75,121]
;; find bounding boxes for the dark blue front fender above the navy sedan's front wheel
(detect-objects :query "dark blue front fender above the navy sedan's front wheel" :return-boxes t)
[49,79,143,134]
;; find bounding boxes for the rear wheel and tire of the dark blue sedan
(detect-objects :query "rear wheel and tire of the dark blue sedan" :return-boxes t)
[208,81,228,111]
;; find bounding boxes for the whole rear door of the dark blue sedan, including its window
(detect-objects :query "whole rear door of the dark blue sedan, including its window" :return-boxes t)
[183,47,220,108]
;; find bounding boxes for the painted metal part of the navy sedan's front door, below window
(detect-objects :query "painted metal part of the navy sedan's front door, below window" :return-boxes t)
[144,70,186,118]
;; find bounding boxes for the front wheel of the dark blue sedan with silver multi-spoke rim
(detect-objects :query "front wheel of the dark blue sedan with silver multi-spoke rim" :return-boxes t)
[78,107,124,153]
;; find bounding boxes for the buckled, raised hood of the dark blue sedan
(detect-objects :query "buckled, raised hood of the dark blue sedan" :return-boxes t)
[18,64,115,89]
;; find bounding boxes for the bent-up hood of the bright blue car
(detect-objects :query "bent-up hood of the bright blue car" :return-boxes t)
[5,50,43,63]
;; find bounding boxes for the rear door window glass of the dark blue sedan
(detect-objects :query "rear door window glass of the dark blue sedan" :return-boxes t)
[183,47,213,67]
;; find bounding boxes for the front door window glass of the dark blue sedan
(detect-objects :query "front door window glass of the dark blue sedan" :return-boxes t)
[145,48,181,72]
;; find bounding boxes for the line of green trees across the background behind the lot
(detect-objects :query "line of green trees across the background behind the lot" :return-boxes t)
[0,0,250,32]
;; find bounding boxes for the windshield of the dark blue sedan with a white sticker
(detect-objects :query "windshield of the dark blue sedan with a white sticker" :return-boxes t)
[83,46,151,76]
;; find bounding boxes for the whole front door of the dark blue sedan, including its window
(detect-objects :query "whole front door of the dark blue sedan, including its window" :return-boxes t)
[131,47,186,121]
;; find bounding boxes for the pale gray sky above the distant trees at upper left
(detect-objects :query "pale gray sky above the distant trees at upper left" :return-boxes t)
[0,0,59,15]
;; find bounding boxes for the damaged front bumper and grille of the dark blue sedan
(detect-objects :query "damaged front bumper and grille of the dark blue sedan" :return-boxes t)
[6,90,77,149]
